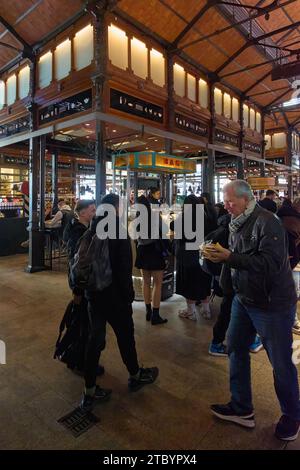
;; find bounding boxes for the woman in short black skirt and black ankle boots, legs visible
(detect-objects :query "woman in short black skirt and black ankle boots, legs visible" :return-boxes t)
[135,194,168,325]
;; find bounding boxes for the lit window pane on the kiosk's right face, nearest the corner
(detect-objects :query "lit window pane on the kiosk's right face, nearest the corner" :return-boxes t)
[108,25,128,70]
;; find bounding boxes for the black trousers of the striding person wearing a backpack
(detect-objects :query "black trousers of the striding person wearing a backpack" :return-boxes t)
[84,293,139,388]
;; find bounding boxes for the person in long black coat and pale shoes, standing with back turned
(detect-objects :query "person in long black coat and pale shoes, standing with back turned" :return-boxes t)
[170,194,211,321]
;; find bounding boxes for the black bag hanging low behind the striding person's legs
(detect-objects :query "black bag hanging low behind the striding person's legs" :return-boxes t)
[53,300,88,370]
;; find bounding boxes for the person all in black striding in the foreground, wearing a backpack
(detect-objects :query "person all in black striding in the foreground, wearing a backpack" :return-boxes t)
[81,194,159,410]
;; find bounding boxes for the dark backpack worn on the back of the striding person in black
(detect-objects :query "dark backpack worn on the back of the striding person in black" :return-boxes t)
[70,229,112,291]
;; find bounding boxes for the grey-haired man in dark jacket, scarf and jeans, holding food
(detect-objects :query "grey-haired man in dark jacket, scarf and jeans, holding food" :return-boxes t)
[204,180,300,440]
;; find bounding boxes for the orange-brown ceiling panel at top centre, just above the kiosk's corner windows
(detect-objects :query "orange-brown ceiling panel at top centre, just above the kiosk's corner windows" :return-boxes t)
[118,0,186,42]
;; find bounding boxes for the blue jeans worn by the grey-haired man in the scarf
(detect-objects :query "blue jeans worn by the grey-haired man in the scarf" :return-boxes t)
[228,296,300,421]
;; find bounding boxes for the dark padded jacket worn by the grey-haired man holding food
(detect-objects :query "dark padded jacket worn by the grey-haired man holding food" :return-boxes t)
[221,206,297,313]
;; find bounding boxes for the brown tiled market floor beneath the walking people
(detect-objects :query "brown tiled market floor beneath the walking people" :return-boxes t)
[0,255,300,450]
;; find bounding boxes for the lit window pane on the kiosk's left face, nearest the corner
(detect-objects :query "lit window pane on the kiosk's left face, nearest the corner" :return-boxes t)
[74,24,94,70]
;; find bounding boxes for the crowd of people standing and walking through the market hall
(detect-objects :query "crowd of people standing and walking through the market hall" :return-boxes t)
[50,180,300,440]
